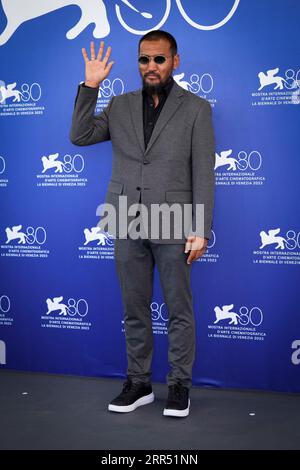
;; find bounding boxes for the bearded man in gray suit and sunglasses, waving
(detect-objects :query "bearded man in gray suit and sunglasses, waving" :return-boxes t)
[70,30,215,417]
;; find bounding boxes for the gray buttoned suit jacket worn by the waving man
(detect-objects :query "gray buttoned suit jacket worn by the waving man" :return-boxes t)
[70,82,215,243]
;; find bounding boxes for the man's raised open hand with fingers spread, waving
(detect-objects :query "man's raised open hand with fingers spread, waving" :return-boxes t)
[82,41,114,88]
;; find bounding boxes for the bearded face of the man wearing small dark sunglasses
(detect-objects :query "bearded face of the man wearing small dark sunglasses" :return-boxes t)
[139,39,179,93]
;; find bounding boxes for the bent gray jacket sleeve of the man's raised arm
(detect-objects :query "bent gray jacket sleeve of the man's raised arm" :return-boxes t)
[70,84,114,145]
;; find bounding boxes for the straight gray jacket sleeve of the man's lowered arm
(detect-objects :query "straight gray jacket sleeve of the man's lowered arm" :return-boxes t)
[192,101,215,239]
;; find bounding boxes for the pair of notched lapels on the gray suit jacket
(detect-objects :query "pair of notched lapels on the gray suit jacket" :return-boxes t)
[130,82,184,155]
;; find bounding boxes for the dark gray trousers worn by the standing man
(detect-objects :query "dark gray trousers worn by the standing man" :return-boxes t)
[114,238,195,388]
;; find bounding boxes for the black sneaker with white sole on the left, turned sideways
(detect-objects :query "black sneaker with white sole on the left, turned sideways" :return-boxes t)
[108,379,154,413]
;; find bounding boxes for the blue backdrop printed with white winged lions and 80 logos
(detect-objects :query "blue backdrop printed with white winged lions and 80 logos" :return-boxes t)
[0,0,300,392]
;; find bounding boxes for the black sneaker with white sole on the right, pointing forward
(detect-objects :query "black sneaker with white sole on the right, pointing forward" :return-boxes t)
[163,383,190,418]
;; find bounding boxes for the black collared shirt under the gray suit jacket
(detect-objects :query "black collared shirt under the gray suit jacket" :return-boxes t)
[143,76,174,148]
